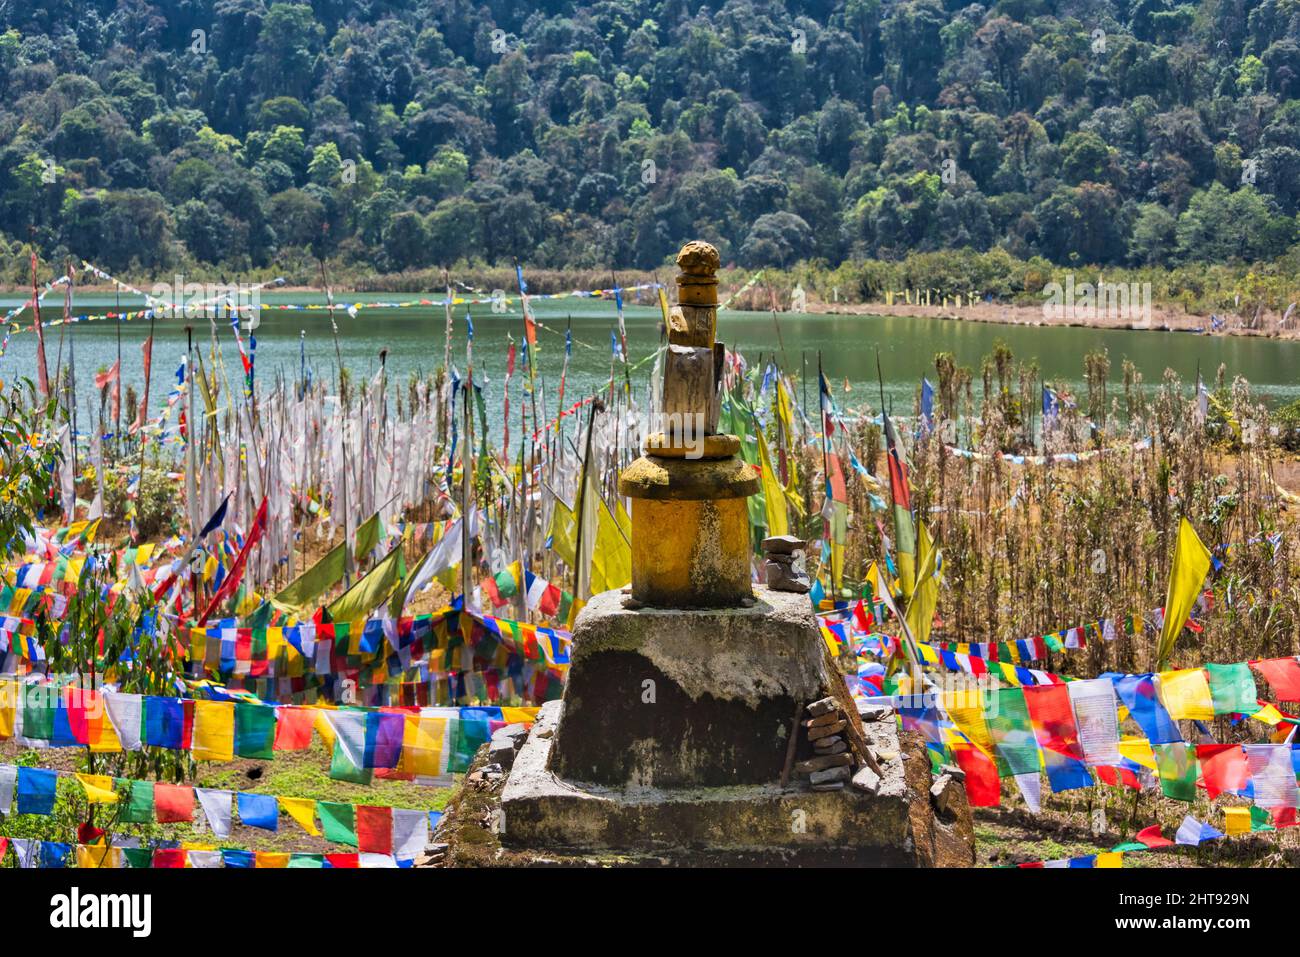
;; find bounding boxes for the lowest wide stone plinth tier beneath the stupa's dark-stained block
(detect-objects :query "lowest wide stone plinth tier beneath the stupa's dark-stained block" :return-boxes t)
[496,701,974,866]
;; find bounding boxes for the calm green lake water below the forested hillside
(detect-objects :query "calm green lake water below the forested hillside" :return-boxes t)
[0,293,1300,429]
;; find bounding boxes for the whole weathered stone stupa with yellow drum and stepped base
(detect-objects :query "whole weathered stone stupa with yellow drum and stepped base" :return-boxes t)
[502,242,974,865]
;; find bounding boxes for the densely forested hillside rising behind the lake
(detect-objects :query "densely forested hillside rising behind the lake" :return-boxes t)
[0,0,1300,276]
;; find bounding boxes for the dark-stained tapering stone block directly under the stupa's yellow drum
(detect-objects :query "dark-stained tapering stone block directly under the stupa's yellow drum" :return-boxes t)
[548,588,826,787]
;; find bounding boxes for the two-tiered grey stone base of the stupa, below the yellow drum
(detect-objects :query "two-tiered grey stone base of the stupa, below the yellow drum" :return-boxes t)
[499,588,974,866]
